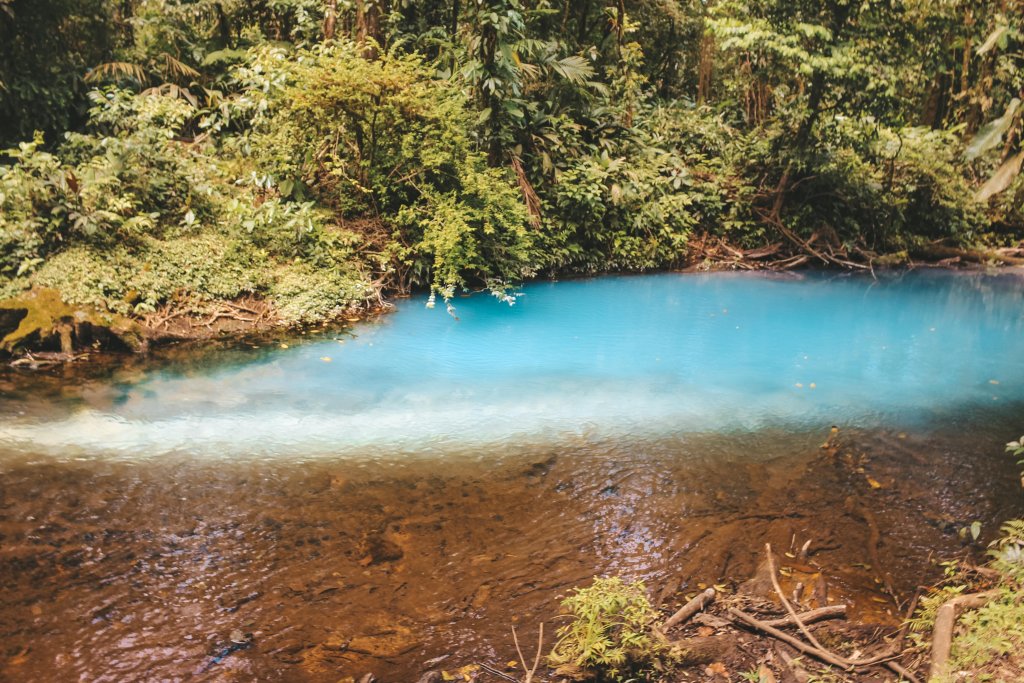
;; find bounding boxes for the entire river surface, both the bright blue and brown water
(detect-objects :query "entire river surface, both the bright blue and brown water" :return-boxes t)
[0,273,1024,683]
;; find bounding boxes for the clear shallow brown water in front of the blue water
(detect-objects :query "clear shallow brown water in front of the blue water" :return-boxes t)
[0,425,1024,683]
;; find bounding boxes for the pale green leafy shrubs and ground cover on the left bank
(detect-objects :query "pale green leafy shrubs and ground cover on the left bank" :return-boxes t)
[0,81,370,324]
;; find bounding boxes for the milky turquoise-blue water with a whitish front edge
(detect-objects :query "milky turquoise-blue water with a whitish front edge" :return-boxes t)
[0,271,1024,458]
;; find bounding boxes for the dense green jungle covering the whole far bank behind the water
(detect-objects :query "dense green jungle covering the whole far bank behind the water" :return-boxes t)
[0,0,1024,339]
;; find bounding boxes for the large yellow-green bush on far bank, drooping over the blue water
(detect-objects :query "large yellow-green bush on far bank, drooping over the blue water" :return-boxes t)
[248,43,534,297]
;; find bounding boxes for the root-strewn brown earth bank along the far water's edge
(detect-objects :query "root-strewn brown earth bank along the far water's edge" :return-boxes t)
[0,253,1024,369]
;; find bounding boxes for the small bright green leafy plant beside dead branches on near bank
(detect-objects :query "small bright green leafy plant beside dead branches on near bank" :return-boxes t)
[548,577,667,681]
